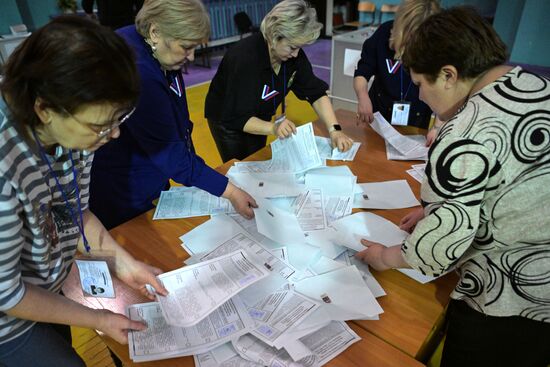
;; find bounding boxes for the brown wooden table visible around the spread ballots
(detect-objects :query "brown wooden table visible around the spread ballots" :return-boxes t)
[63,110,456,367]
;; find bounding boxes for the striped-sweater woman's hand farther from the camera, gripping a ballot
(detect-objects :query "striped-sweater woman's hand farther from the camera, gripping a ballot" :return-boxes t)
[116,255,168,300]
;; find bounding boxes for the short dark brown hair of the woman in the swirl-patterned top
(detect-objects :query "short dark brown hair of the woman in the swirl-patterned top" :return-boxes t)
[403,6,506,83]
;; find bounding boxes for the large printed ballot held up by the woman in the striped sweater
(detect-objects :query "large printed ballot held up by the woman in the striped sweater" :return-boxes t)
[156,250,270,327]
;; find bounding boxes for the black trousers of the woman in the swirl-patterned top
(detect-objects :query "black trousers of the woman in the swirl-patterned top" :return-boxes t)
[441,300,550,367]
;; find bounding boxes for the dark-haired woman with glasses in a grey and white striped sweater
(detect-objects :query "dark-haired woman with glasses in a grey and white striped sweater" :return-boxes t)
[0,17,165,367]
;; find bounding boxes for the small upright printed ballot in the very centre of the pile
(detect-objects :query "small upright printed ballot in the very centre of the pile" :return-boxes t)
[292,189,327,232]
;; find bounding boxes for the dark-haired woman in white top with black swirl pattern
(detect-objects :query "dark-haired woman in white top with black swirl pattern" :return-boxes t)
[358,7,550,367]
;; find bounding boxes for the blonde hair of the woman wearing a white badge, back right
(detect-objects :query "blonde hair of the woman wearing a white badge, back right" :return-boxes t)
[390,0,441,59]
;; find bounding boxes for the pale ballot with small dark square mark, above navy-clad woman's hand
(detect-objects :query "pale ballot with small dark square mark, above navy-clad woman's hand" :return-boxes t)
[227,172,305,198]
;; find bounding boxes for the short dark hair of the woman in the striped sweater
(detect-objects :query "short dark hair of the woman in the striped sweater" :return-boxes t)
[0,16,139,131]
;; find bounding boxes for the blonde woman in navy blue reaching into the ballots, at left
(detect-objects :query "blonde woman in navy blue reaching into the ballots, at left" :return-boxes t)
[90,0,256,228]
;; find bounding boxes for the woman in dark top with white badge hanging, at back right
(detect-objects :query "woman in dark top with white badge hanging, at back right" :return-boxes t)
[353,0,441,143]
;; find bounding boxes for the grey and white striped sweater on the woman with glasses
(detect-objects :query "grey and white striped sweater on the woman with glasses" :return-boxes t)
[0,98,93,343]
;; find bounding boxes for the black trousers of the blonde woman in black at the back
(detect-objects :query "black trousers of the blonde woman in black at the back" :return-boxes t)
[208,119,267,163]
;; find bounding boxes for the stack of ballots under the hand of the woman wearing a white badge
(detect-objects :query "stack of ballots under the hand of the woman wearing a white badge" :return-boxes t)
[370,112,428,160]
